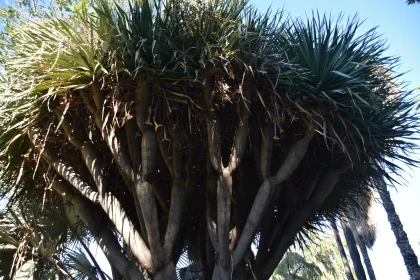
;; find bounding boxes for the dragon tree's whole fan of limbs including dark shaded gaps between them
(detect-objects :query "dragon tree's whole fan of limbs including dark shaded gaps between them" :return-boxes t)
[23,77,358,280]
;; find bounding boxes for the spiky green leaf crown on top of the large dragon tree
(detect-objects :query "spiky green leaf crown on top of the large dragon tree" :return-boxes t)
[0,1,414,195]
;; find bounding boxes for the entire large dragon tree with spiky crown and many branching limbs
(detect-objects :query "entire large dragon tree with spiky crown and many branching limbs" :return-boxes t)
[0,0,418,280]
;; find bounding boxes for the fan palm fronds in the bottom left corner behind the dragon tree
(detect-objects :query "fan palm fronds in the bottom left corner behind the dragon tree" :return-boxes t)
[0,199,109,280]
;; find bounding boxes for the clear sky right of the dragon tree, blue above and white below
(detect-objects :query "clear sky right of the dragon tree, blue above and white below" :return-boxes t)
[251,0,420,280]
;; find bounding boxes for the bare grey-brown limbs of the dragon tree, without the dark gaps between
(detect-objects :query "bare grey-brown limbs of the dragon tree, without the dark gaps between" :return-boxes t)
[29,71,360,280]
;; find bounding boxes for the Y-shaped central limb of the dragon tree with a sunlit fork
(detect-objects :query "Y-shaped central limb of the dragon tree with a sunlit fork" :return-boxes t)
[203,74,254,280]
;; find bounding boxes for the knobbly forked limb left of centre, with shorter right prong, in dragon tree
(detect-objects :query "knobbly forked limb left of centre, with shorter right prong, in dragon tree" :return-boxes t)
[135,80,179,279]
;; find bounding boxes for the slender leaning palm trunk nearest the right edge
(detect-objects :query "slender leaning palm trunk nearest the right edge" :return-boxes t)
[379,181,420,280]
